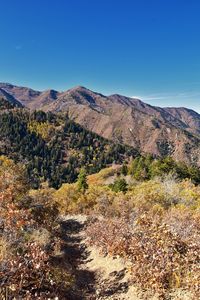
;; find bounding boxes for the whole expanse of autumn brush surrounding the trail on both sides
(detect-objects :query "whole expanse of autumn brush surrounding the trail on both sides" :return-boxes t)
[0,157,200,300]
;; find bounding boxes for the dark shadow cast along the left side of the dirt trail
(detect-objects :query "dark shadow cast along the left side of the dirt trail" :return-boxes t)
[57,219,96,300]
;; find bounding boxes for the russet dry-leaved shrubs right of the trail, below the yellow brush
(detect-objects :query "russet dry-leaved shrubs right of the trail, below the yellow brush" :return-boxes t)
[87,212,200,299]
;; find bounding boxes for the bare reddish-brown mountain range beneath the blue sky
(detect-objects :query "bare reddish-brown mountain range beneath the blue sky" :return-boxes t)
[0,83,200,165]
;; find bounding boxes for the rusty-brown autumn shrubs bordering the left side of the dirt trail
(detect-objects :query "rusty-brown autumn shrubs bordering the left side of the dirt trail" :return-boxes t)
[0,157,71,299]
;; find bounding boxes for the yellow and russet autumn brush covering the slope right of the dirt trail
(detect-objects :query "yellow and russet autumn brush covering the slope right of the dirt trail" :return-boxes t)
[82,177,200,299]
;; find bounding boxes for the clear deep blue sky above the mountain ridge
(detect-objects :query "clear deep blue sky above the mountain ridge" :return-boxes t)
[0,0,200,111]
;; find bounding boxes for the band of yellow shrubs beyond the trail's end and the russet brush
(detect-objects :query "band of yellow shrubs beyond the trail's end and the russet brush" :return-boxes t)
[54,173,200,216]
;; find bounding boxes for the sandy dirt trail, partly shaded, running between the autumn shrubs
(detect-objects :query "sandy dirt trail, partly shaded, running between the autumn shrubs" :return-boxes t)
[61,215,141,300]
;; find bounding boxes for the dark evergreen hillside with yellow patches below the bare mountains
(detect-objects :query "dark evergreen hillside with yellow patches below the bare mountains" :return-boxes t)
[0,100,137,188]
